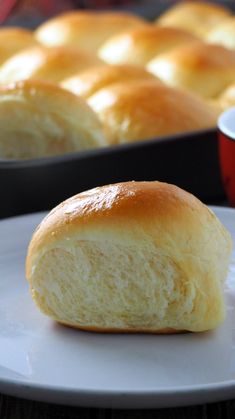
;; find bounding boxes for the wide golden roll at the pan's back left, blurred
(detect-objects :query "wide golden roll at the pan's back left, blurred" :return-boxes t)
[35,10,146,52]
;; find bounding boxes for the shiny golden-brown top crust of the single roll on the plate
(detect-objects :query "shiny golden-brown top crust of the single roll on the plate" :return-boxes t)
[26,182,228,277]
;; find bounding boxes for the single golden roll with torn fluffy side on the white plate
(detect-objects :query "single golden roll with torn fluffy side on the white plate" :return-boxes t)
[26,182,232,333]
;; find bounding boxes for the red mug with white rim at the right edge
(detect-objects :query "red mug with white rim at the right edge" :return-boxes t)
[218,107,235,207]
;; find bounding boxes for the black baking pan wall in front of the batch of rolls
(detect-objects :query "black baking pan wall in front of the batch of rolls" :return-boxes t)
[0,130,224,218]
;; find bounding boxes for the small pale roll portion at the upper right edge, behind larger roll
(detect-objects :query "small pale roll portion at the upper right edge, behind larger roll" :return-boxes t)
[205,16,235,49]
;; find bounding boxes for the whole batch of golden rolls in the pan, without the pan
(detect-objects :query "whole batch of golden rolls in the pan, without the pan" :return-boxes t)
[0,1,235,159]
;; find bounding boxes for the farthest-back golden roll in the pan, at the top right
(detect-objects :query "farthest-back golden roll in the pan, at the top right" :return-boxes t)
[156,1,231,36]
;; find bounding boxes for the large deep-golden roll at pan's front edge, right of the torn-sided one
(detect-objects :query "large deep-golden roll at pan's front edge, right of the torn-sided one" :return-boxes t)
[88,80,218,144]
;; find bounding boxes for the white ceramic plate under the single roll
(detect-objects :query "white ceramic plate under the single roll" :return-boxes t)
[0,208,235,408]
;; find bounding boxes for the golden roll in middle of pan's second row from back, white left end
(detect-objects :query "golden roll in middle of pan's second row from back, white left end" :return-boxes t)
[98,25,197,66]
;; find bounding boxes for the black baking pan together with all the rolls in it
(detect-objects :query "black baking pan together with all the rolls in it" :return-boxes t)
[0,1,235,217]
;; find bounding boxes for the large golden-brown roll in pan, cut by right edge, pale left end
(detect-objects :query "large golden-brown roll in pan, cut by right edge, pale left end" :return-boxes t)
[147,42,235,98]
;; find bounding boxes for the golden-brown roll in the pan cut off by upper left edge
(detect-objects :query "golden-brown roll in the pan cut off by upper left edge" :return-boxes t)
[0,27,38,65]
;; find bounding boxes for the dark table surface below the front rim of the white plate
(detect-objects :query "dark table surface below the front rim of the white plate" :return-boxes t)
[0,395,235,419]
